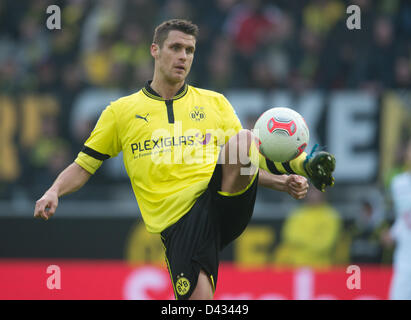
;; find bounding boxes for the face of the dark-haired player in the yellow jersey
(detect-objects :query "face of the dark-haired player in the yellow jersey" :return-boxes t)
[152,30,196,83]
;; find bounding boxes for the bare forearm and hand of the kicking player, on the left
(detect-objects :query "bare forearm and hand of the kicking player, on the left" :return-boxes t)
[34,162,91,220]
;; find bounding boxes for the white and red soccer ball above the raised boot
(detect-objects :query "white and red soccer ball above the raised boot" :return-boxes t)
[254,108,310,162]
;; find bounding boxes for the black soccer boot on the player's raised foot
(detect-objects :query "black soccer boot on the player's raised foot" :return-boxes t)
[304,151,335,192]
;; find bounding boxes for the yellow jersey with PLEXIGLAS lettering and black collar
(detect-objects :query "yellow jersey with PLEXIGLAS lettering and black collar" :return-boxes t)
[75,83,242,233]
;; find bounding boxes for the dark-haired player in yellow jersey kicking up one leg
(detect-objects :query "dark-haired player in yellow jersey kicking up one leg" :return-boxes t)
[34,19,334,299]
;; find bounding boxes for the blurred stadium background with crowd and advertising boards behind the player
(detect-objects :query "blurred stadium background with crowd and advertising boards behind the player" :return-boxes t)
[0,0,411,299]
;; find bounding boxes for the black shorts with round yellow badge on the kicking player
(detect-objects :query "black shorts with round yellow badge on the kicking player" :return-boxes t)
[161,164,258,299]
